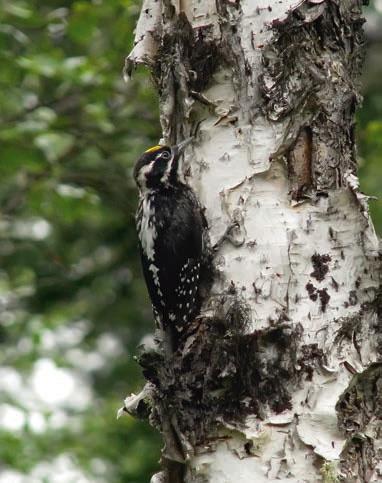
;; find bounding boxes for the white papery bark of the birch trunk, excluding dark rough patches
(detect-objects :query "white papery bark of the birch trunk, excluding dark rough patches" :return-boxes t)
[128,0,381,483]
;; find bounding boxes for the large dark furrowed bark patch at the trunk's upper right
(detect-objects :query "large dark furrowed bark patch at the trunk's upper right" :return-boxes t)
[259,0,364,190]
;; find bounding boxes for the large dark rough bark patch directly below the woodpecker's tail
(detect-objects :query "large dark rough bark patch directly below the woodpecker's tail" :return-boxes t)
[140,295,302,444]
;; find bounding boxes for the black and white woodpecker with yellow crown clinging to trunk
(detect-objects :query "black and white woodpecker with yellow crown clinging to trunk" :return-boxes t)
[134,138,206,349]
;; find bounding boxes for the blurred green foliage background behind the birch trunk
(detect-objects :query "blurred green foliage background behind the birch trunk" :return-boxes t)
[0,0,382,483]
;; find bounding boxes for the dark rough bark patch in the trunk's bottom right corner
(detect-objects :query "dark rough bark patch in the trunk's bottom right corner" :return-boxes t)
[336,362,382,481]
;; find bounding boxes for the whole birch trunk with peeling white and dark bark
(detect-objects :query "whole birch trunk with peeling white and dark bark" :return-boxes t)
[126,0,382,483]
